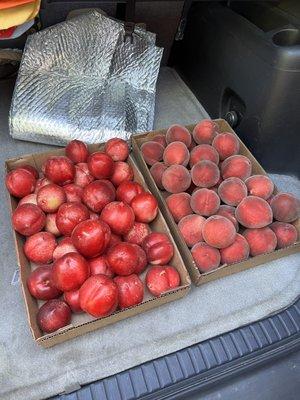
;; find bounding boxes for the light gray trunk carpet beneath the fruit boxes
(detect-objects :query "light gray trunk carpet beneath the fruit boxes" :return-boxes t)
[0,68,300,400]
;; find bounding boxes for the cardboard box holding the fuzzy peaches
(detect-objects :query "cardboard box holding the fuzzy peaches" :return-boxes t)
[132,119,300,285]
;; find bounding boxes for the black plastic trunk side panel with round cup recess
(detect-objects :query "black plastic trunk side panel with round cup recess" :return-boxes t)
[177,2,300,177]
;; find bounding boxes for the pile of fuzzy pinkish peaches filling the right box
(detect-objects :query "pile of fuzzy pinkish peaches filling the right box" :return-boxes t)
[141,120,300,272]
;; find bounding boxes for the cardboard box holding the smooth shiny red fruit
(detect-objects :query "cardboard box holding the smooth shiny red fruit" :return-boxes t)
[5,145,191,347]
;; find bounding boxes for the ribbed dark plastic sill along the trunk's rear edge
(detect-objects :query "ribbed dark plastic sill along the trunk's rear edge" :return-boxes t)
[52,299,300,400]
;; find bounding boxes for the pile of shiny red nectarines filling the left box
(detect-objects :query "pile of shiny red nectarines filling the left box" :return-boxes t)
[6,139,180,333]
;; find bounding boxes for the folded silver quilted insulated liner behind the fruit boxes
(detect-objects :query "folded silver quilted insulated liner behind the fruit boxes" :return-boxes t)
[10,11,163,145]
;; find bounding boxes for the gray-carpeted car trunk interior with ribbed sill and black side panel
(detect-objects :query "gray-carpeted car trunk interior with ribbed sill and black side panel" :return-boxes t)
[0,0,300,400]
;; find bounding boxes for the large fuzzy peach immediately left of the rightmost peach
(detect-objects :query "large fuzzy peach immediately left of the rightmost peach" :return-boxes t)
[235,196,273,228]
